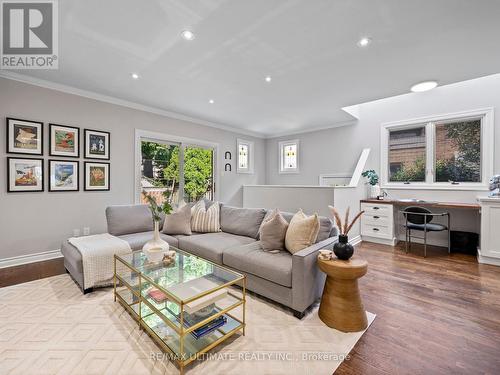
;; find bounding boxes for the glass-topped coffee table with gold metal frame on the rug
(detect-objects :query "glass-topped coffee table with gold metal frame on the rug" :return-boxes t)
[114,247,246,374]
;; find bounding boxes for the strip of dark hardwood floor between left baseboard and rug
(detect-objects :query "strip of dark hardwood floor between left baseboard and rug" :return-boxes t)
[0,258,66,288]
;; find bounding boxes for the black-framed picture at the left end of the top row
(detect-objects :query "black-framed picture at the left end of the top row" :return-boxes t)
[7,117,43,155]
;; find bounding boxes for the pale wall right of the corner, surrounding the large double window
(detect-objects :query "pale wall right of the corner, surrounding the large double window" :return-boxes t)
[266,74,500,244]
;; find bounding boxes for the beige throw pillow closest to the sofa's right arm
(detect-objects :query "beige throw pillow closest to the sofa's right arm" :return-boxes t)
[285,210,320,254]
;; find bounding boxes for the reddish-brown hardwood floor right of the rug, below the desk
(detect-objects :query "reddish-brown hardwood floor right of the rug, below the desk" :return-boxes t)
[335,243,500,374]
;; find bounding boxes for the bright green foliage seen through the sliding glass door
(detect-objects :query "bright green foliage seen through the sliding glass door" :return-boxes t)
[163,147,213,200]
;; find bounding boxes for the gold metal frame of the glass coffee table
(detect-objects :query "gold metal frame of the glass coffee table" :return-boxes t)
[113,249,246,375]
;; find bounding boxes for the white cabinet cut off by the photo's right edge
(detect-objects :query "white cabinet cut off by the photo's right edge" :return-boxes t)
[478,198,500,266]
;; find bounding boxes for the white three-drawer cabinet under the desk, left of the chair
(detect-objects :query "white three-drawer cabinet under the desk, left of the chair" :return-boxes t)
[361,202,396,245]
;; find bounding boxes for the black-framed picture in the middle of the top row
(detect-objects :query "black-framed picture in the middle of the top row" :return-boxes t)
[49,124,80,158]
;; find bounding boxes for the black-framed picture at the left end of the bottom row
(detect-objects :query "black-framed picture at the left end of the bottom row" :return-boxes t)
[7,158,43,193]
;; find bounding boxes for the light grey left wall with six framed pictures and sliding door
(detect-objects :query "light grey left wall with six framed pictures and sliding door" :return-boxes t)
[0,79,266,260]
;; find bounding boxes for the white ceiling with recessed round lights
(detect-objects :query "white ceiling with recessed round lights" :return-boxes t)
[8,0,500,136]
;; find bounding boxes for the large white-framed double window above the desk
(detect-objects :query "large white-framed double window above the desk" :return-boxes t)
[380,108,494,190]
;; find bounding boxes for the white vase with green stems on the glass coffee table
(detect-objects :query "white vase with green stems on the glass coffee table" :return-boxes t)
[142,190,175,262]
